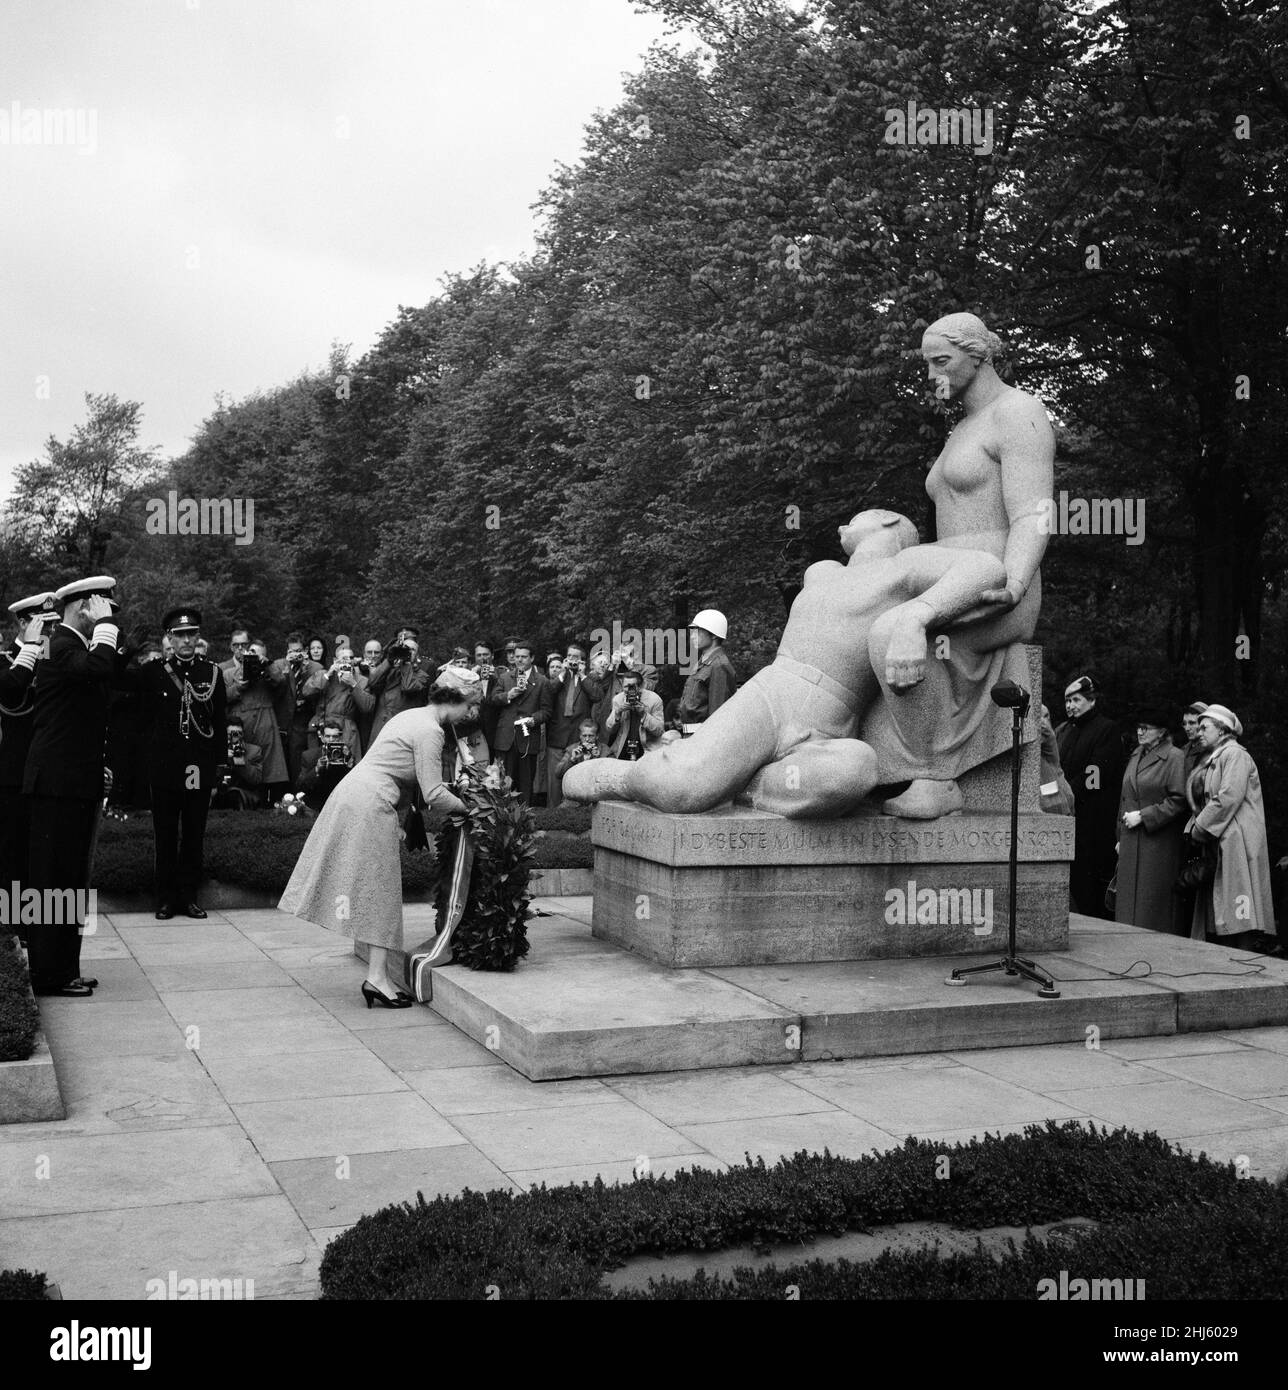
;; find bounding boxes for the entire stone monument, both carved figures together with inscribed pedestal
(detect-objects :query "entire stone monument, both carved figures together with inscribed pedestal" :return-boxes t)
[563,314,1073,966]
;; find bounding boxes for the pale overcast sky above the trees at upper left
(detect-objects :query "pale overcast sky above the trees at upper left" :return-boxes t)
[0,0,683,496]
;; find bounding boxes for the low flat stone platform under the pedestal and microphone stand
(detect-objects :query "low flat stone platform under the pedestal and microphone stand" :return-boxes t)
[419,898,1288,1081]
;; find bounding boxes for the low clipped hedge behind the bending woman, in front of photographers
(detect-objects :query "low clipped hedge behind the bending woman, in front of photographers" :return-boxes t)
[94,806,593,897]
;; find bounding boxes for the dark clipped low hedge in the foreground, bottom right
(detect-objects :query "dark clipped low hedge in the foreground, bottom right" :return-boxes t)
[321,1120,1288,1300]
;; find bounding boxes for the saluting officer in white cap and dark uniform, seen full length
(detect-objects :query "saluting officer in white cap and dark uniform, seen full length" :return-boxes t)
[22,574,122,998]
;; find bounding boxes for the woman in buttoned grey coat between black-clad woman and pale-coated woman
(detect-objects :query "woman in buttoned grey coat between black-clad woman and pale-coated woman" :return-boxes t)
[1114,710,1189,933]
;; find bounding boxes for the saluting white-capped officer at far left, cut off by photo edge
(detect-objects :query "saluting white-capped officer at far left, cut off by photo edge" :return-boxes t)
[0,594,58,945]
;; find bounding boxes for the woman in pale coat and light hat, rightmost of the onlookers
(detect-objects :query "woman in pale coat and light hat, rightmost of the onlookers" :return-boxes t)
[1185,705,1274,944]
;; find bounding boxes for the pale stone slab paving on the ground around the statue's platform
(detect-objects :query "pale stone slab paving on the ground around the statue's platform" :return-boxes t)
[0,898,1288,1298]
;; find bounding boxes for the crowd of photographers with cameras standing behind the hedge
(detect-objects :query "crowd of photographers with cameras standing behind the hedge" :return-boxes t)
[107,612,736,810]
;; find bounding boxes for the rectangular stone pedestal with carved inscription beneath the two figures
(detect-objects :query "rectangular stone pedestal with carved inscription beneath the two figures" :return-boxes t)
[592,801,1074,967]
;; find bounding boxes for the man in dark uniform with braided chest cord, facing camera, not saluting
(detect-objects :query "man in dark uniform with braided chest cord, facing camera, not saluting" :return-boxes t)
[128,605,228,922]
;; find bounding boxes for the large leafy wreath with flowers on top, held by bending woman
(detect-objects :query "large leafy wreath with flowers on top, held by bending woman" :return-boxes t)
[434,765,536,970]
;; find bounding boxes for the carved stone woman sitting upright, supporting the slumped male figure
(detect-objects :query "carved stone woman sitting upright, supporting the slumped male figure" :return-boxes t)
[860,314,1055,820]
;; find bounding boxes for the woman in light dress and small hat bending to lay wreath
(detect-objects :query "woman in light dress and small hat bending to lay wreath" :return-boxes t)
[278,666,481,1009]
